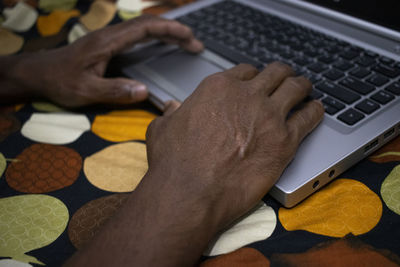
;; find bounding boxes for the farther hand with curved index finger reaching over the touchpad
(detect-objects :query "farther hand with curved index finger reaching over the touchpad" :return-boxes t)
[7,16,203,107]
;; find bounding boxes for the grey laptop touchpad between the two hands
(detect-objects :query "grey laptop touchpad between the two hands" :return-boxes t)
[140,50,223,101]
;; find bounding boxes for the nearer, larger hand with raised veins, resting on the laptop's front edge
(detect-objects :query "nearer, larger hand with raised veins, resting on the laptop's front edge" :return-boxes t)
[146,63,324,231]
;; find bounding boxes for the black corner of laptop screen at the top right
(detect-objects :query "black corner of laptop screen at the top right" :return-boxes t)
[303,0,400,31]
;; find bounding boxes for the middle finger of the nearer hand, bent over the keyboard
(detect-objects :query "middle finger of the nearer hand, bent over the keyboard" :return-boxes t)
[252,62,294,95]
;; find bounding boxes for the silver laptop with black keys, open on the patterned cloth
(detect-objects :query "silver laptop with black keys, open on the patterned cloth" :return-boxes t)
[123,0,400,208]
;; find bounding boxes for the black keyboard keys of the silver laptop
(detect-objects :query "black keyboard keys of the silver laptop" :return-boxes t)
[178,1,400,126]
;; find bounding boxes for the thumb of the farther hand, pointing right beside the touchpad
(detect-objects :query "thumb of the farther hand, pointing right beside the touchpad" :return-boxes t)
[91,77,148,104]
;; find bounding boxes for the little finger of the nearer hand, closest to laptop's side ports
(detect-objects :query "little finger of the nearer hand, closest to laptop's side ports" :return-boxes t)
[287,100,324,143]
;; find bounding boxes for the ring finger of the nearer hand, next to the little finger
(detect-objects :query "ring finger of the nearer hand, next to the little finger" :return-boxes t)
[271,76,312,115]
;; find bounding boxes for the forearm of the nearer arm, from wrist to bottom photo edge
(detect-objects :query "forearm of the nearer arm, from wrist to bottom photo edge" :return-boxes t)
[68,174,219,266]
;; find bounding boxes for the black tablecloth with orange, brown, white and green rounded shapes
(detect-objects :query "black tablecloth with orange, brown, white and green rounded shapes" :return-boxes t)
[0,0,400,267]
